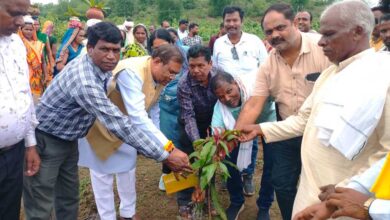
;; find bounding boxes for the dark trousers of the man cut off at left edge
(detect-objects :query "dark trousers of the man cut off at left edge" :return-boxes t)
[0,141,25,220]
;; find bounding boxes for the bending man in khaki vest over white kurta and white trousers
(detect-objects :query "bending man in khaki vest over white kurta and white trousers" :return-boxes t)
[79,45,183,220]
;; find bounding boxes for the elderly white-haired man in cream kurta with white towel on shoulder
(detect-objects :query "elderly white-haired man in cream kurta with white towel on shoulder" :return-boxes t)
[242,1,390,217]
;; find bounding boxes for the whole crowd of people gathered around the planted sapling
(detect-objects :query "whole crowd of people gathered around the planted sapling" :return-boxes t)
[0,0,390,220]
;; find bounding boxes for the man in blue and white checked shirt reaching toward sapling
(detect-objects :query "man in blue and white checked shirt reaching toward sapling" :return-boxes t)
[24,22,191,220]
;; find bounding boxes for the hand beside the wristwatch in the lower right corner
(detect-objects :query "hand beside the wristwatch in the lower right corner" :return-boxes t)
[326,187,370,219]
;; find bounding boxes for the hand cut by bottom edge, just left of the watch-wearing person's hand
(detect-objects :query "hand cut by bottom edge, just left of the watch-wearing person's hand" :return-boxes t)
[293,202,335,220]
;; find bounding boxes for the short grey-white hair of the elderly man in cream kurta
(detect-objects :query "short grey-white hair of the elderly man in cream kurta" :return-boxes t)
[320,0,375,38]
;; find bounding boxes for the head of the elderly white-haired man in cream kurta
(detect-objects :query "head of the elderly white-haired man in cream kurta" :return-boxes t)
[318,1,374,64]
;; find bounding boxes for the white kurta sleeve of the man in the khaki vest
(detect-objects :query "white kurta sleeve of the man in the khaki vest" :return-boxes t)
[117,69,168,146]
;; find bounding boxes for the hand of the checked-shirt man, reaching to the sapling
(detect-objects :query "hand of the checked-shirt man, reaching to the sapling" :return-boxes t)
[164,148,192,174]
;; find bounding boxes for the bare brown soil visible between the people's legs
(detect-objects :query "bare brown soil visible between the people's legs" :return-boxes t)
[79,149,281,220]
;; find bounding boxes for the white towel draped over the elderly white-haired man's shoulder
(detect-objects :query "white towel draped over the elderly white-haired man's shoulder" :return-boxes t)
[315,52,390,160]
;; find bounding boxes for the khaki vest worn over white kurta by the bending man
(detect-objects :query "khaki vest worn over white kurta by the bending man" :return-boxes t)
[86,56,163,160]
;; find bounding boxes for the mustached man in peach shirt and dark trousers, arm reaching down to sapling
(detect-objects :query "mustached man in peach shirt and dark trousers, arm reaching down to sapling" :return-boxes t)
[236,4,330,220]
